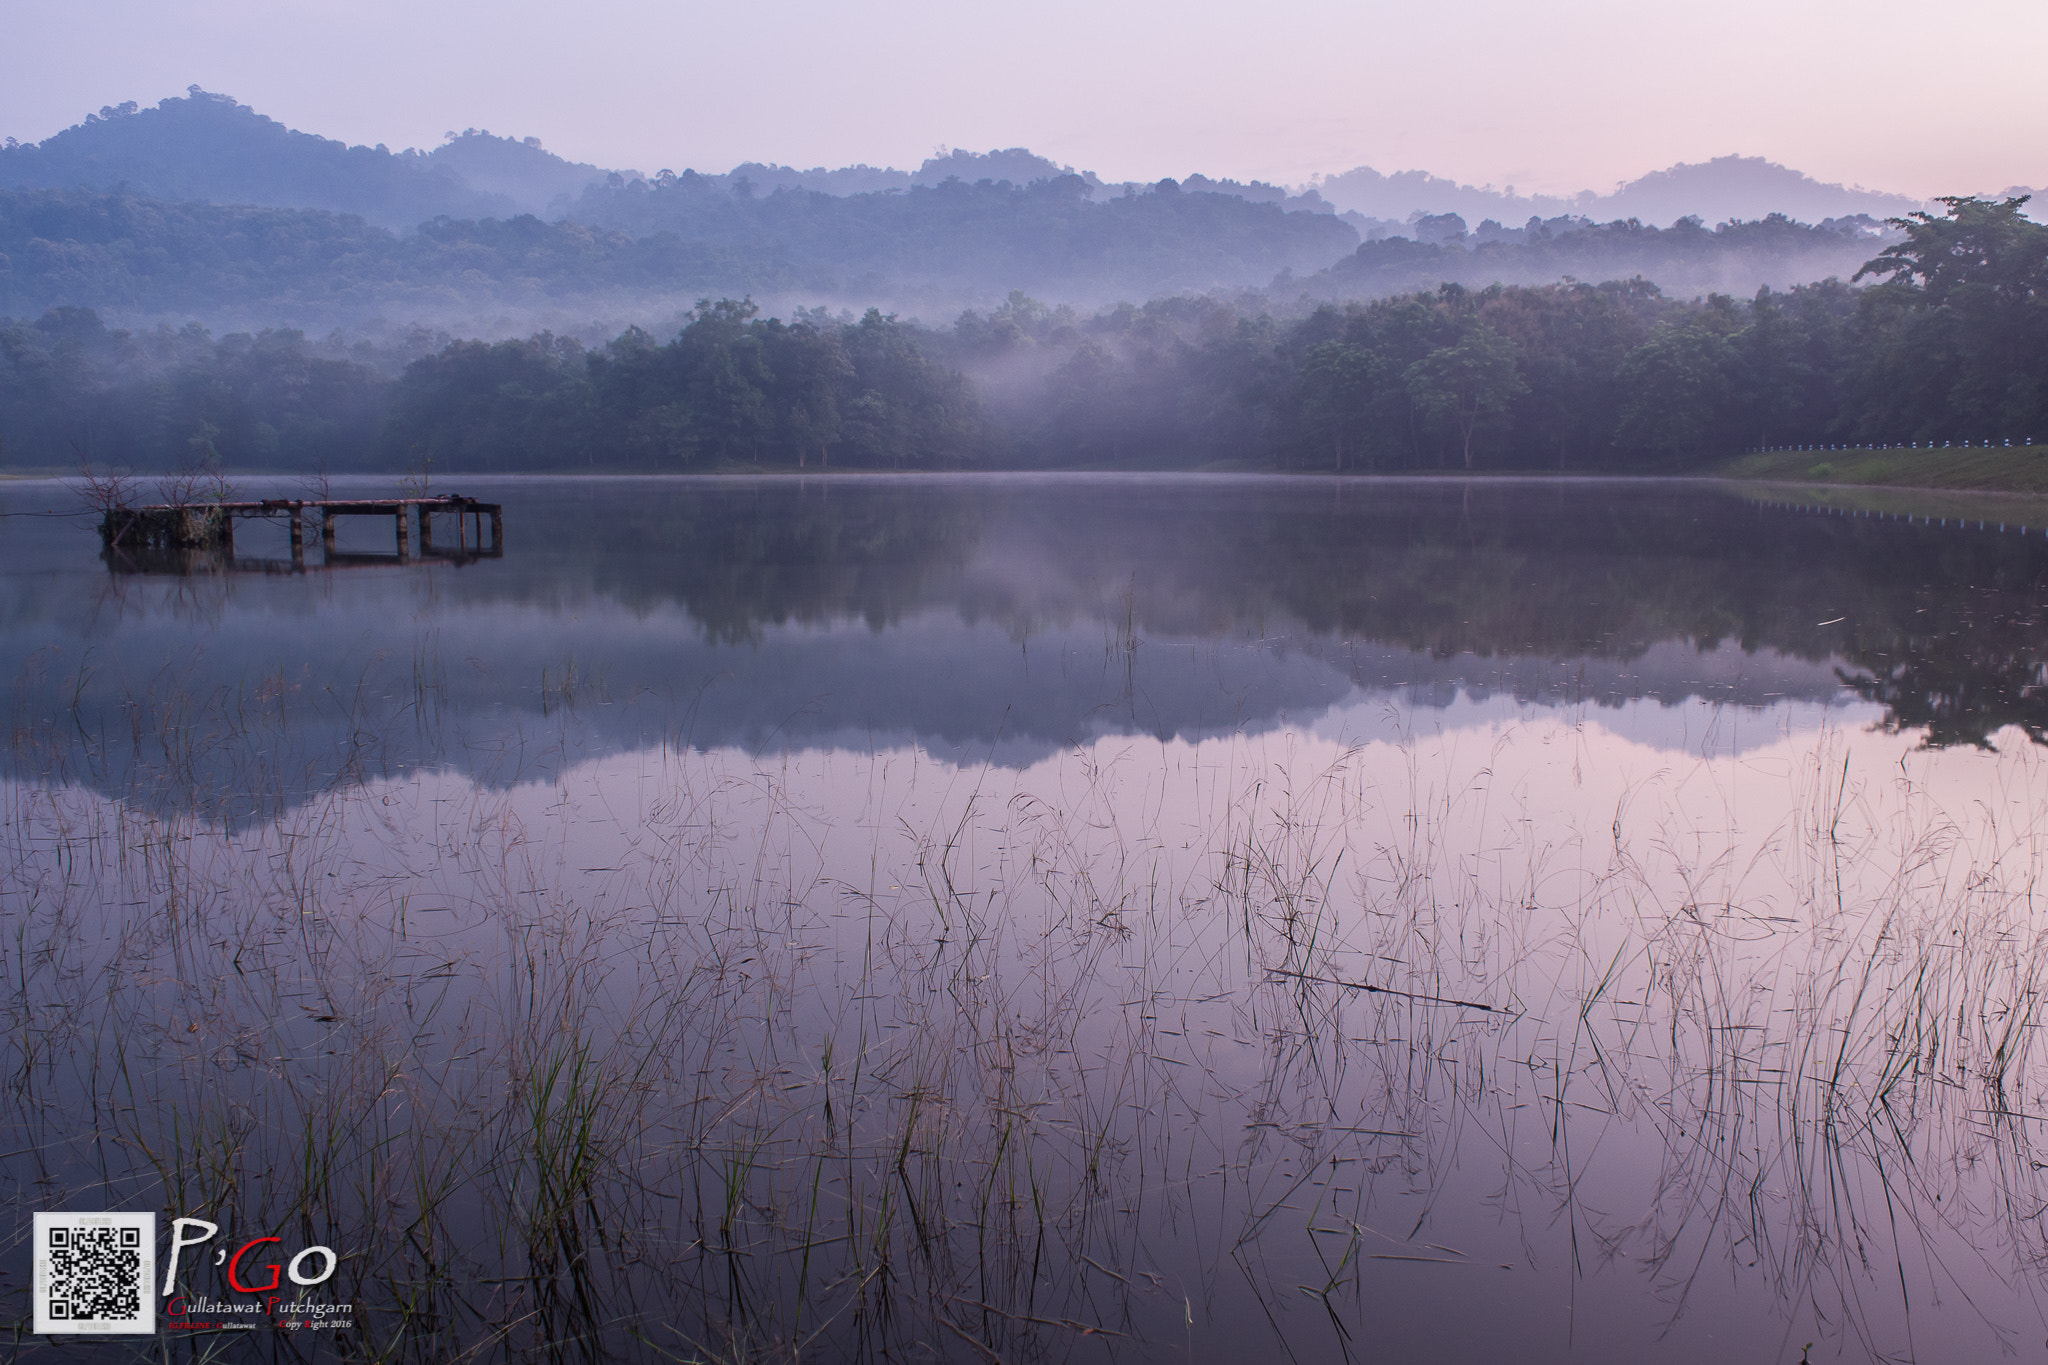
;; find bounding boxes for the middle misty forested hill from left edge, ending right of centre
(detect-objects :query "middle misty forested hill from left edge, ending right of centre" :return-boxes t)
[0,178,1358,329]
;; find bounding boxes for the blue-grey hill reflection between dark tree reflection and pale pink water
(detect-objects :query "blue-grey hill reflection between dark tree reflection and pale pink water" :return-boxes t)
[4,602,1875,802]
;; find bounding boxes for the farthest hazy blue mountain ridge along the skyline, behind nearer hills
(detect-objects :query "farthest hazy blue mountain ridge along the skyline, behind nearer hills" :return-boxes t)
[0,86,1974,237]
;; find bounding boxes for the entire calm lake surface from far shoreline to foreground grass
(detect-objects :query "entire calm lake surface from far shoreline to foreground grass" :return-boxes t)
[0,477,2048,1363]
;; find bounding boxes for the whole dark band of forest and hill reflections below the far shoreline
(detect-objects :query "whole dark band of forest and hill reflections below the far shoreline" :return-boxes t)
[0,477,2048,789]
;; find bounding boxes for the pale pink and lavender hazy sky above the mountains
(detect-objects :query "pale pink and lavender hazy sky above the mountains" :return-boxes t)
[0,0,2048,194]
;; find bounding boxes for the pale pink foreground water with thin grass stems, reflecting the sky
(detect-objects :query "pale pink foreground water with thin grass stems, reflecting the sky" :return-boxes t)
[0,687,2048,1359]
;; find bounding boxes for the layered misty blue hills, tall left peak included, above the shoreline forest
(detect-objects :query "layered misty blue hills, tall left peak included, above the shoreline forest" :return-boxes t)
[0,88,1916,336]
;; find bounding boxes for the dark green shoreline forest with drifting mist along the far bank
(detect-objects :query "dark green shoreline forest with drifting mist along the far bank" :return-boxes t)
[0,199,2048,471]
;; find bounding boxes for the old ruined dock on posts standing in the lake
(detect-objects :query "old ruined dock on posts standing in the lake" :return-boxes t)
[100,493,504,573]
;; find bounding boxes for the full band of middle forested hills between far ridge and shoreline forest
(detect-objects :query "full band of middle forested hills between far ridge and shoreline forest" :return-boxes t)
[0,178,1882,332]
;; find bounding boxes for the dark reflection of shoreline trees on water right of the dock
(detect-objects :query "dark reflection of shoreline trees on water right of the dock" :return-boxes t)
[520,479,2048,745]
